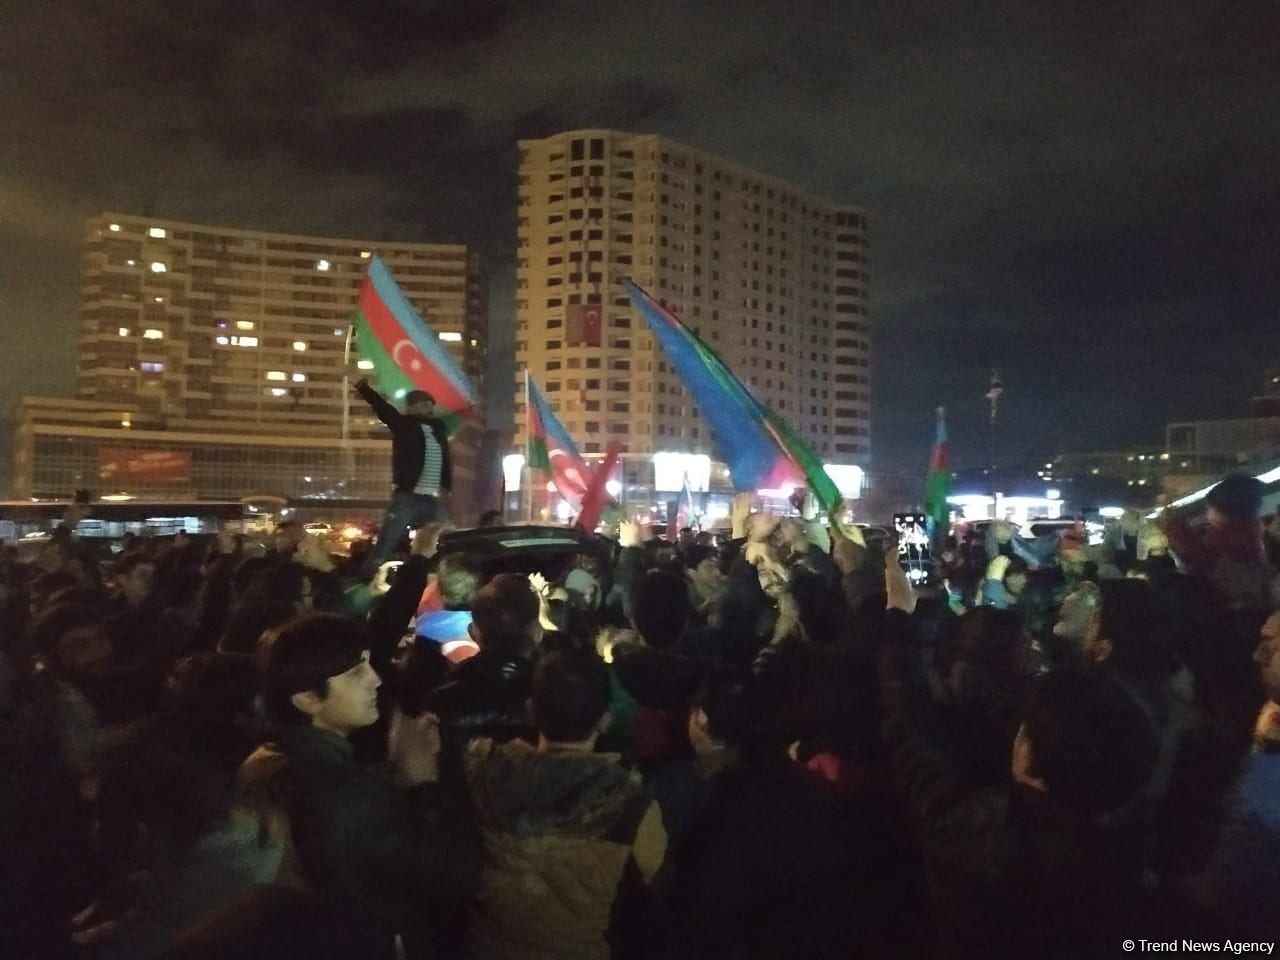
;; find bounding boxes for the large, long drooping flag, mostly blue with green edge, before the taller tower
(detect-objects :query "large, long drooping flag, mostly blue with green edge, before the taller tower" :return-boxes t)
[625,280,840,516]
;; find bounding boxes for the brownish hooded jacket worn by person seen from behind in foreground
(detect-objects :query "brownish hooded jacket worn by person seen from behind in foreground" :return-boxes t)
[465,740,667,960]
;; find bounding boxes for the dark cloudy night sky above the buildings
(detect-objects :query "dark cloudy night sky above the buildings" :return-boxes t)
[0,0,1280,491]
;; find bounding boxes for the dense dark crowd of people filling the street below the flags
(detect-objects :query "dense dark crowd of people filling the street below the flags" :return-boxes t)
[0,478,1280,960]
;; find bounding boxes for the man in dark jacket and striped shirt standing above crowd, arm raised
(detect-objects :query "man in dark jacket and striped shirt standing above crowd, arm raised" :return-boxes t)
[356,379,453,573]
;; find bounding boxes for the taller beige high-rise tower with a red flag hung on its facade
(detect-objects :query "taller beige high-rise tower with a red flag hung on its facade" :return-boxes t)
[516,131,870,481]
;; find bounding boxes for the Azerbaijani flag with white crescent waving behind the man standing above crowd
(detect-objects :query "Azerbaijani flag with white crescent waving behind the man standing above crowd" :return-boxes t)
[351,253,477,436]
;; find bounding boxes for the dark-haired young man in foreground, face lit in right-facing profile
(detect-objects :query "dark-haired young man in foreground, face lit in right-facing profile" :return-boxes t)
[238,614,481,957]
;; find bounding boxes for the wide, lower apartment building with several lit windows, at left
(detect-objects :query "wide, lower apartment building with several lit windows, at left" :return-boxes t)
[17,212,488,508]
